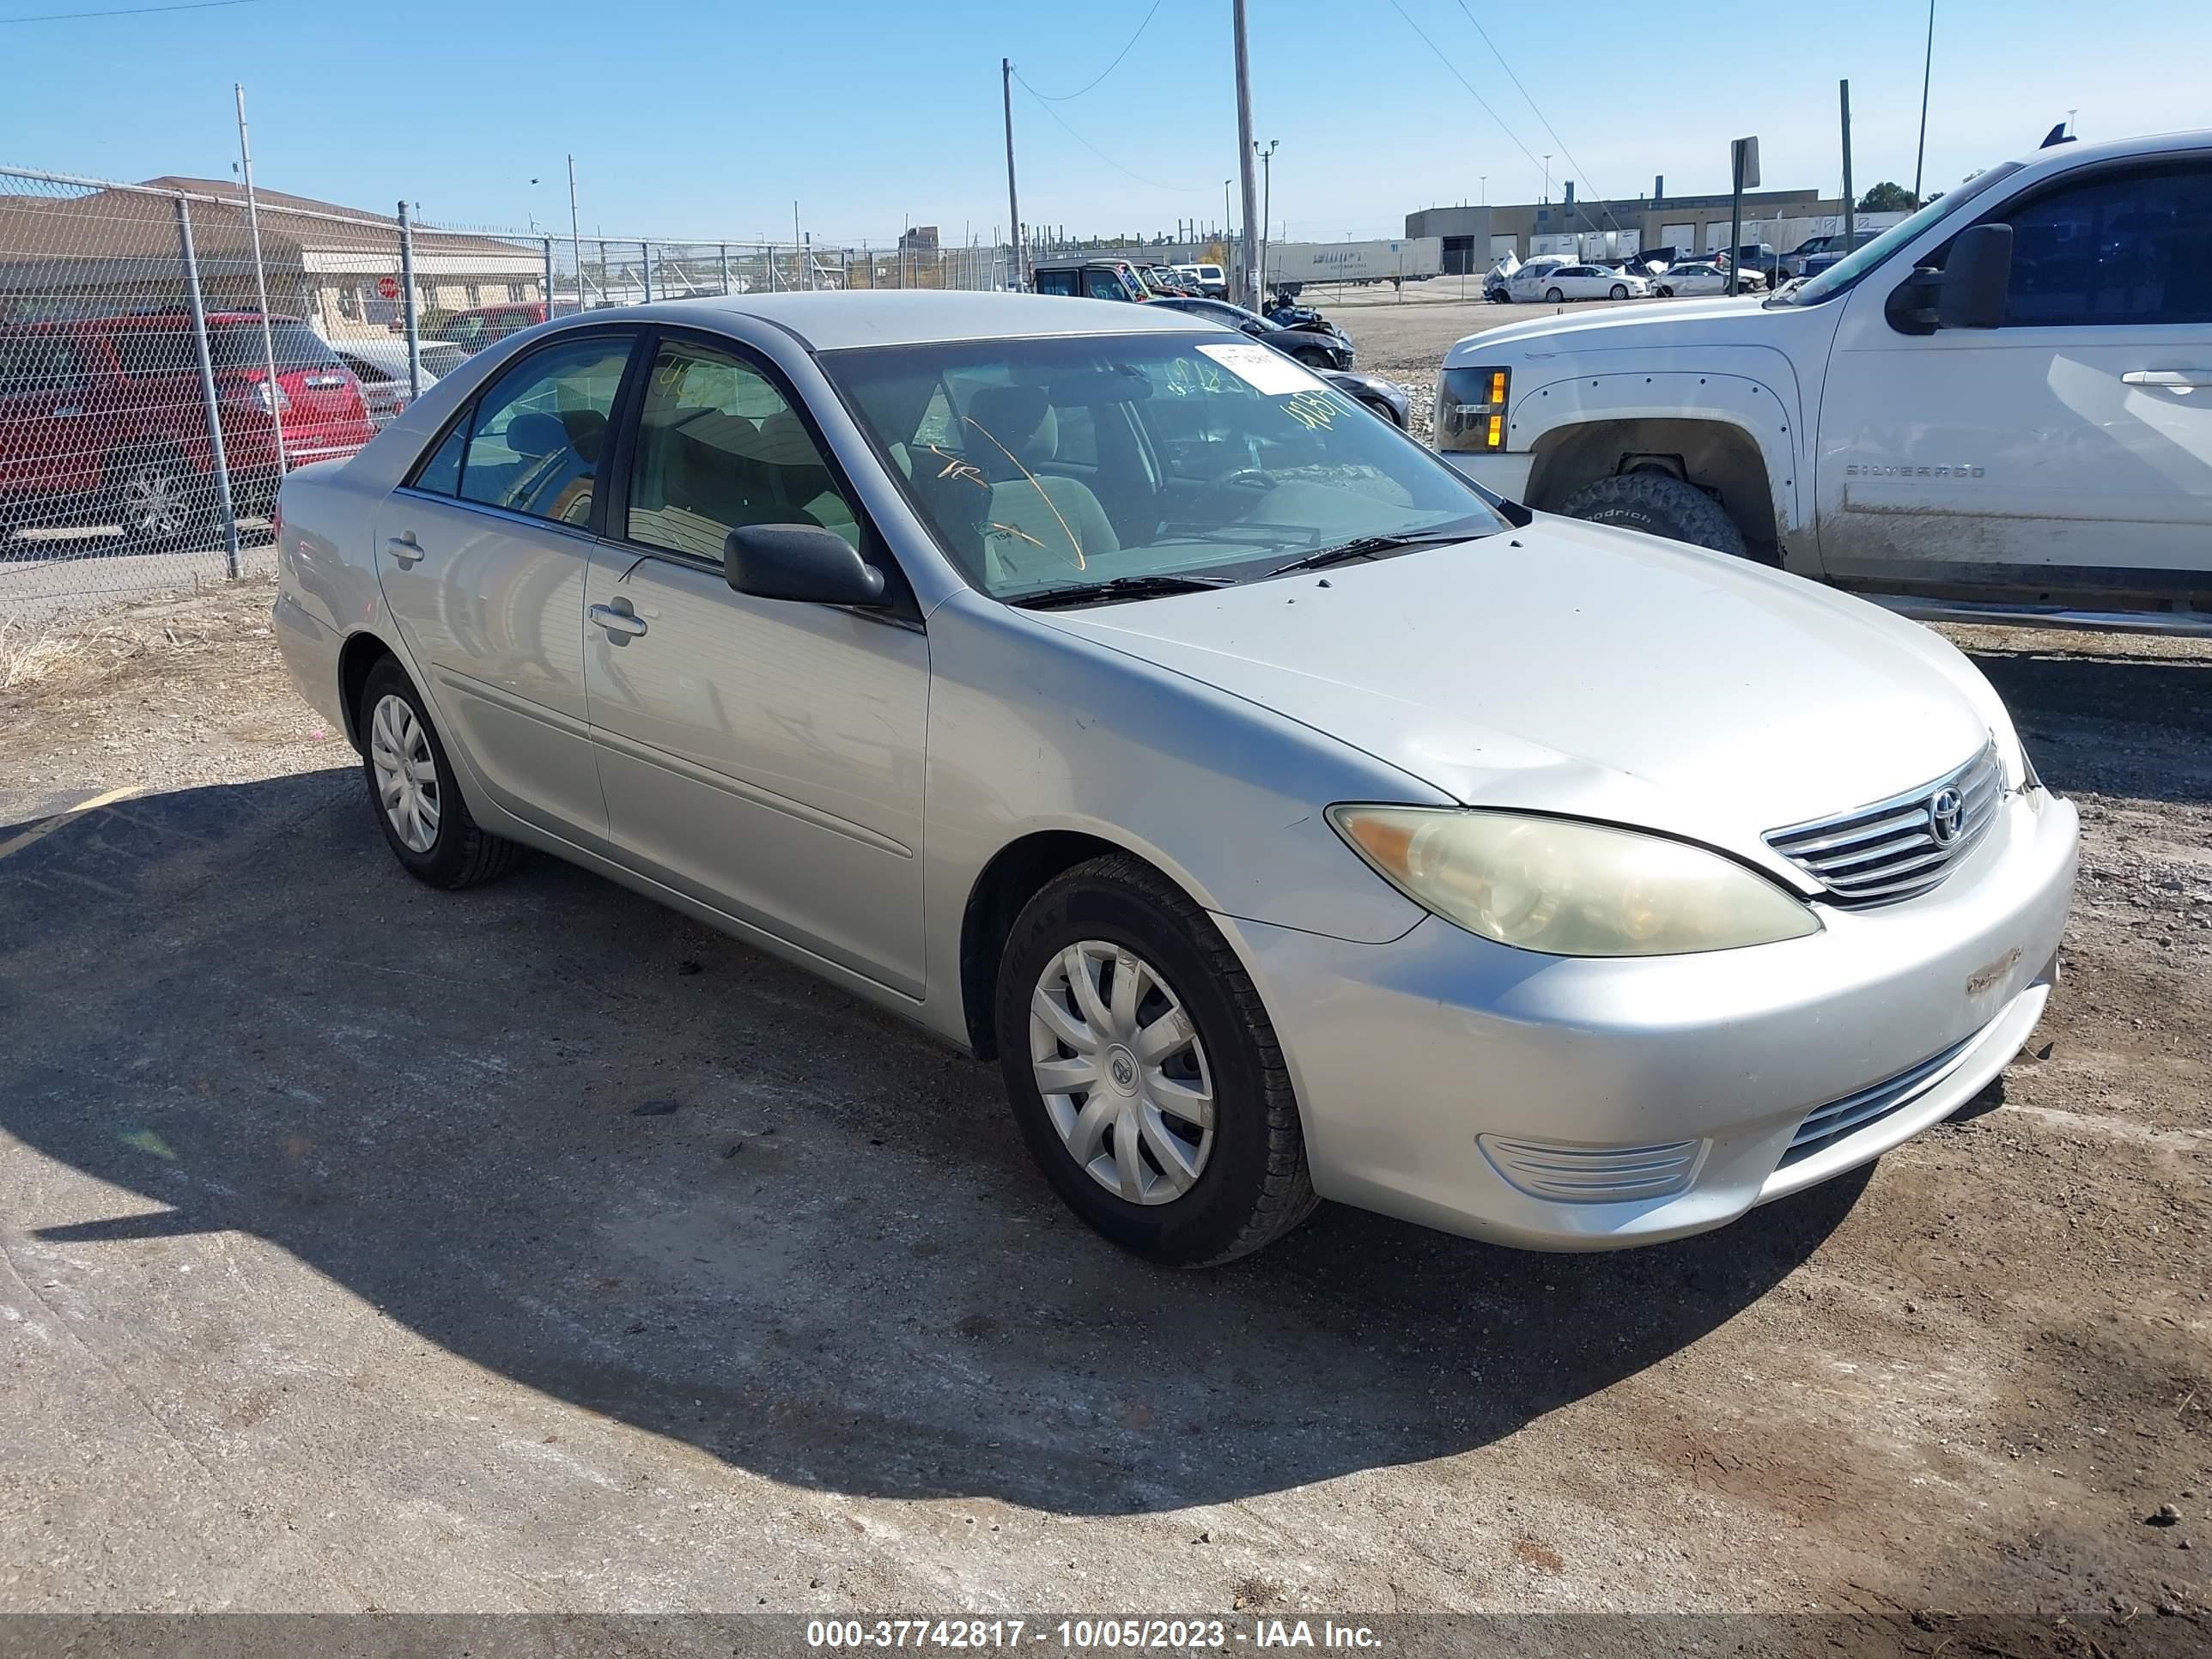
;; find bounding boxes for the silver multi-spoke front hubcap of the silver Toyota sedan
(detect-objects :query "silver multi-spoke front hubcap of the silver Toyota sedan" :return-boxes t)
[1029,940,1214,1203]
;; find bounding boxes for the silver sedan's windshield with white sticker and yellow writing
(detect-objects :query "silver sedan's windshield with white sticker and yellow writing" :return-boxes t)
[823,334,1504,602]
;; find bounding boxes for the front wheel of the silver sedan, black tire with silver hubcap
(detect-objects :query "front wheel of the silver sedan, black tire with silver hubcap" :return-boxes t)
[994,854,1318,1267]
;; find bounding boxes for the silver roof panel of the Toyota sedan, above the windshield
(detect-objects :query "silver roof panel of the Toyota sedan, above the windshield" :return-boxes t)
[586,288,1207,352]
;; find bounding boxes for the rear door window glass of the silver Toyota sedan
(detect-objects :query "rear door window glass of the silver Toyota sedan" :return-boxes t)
[440,334,630,525]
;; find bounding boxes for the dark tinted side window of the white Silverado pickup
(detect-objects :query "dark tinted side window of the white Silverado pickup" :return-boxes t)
[2004,164,2212,327]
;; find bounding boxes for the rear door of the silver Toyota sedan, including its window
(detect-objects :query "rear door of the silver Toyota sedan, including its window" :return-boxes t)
[376,330,637,849]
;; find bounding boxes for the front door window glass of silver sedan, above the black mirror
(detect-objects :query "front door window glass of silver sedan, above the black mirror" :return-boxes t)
[629,341,860,560]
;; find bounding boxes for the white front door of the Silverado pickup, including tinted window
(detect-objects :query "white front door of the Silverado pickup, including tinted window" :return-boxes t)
[1816,153,2212,592]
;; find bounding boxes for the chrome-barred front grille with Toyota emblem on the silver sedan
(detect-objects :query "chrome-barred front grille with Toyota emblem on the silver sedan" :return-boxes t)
[1767,744,2004,905]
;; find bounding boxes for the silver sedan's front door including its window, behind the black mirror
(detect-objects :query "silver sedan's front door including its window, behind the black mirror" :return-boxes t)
[584,331,929,995]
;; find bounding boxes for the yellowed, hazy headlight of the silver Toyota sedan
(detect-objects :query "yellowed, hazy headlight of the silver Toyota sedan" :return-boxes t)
[1328,805,1820,956]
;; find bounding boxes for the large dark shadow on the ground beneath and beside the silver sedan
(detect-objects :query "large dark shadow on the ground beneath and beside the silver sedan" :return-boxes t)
[0,772,1865,1513]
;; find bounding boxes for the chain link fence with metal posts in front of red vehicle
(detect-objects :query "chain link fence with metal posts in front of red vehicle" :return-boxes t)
[0,168,1011,629]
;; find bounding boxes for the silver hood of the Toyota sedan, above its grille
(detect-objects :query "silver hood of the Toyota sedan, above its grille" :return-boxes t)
[1037,515,2008,856]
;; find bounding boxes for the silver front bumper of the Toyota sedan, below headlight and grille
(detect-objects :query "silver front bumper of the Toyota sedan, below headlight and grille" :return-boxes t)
[1221,790,2079,1249]
